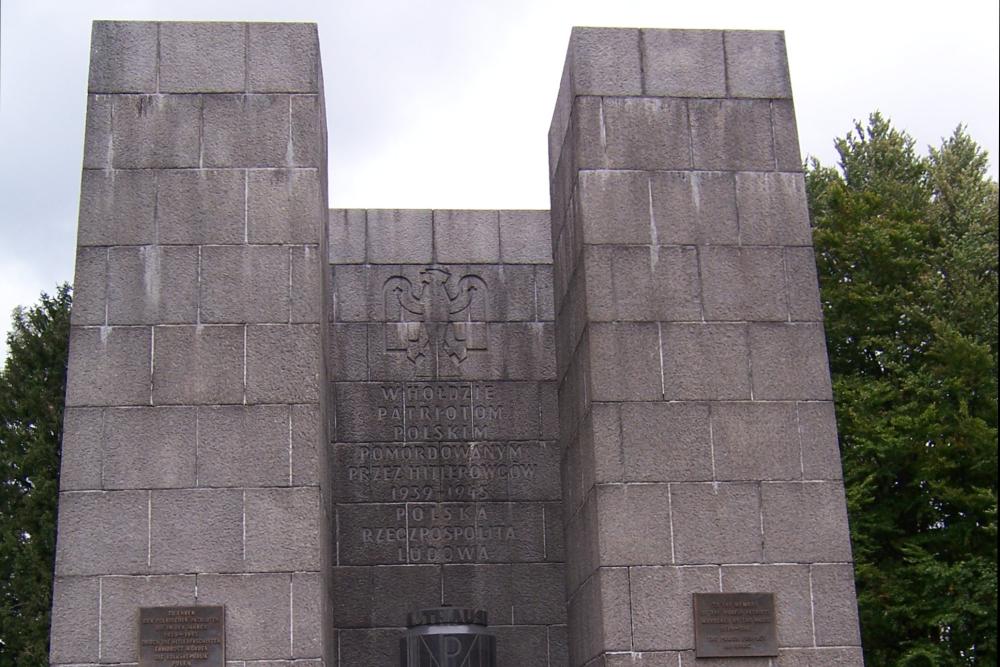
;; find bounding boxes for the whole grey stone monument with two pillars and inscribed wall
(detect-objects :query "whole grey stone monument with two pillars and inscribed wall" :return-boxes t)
[51,22,862,667]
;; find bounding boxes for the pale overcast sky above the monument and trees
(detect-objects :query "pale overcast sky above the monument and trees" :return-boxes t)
[0,0,1000,357]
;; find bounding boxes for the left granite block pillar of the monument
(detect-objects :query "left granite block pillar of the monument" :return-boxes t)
[50,22,332,667]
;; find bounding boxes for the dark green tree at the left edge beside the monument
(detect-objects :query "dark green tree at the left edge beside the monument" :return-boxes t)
[0,284,71,666]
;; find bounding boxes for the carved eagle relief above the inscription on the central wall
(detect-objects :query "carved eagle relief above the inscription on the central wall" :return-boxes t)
[382,266,486,364]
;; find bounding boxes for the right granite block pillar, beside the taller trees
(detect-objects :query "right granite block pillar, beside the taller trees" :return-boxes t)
[549,29,862,667]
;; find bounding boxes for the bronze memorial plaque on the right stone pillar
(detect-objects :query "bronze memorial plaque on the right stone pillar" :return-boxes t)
[694,593,778,658]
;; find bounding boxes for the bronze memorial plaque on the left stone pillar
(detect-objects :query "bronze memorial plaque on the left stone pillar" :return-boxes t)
[139,607,226,667]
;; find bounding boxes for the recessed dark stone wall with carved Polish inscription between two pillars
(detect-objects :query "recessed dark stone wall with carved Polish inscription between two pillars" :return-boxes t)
[327,209,566,667]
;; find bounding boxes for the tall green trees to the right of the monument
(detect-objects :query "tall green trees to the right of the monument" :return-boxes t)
[806,113,998,667]
